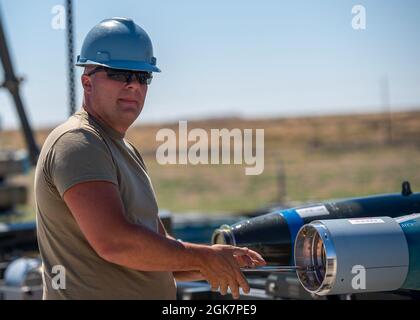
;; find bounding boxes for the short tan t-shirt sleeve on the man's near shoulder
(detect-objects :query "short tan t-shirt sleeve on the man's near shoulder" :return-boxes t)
[46,129,118,197]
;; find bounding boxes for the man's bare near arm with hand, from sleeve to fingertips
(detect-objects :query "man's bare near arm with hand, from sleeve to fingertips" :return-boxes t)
[63,181,265,298]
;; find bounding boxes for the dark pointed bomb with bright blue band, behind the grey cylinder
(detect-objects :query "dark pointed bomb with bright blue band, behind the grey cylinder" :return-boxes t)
[212,183,420,266]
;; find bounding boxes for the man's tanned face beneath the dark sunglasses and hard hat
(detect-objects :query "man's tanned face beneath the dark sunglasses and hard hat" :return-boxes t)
[82,67,147,132]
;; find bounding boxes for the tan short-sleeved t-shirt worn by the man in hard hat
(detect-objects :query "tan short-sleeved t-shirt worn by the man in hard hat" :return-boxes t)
[35,108,176,299]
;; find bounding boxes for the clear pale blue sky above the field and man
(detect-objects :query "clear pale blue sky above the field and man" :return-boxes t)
[0,0,420,128]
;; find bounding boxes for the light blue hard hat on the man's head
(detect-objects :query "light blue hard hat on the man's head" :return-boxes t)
[76,17,160,72]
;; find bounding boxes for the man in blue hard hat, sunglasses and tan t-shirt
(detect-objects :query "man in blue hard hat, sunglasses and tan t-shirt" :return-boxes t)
[35,18,265,299]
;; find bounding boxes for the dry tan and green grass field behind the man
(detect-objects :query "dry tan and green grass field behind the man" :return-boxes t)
[0,112,420,219]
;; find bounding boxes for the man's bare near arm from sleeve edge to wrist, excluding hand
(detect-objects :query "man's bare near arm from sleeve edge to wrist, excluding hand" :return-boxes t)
[64,181,199,271]
